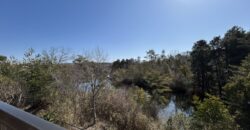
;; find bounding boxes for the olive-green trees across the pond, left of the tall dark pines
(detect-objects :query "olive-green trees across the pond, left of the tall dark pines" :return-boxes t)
[112,50,192,104]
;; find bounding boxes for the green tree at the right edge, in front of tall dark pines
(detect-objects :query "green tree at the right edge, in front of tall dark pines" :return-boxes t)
[225,55,250,129]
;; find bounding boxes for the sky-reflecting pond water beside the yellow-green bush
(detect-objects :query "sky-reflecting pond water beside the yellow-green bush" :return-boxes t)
[158,94,193,120]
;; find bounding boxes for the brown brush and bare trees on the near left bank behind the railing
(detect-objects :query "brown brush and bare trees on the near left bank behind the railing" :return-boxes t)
[0,49,161,130]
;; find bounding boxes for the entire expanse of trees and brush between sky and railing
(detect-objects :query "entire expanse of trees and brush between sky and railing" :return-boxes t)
[0,26,250,130]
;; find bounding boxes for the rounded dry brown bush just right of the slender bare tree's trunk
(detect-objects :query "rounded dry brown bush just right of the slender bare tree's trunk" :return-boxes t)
[97,89,159,130]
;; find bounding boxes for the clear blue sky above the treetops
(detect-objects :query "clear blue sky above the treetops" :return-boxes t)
[0,0,250,61]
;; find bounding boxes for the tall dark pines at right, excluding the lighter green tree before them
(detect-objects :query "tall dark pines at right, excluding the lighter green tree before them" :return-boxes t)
[191,27,250,98]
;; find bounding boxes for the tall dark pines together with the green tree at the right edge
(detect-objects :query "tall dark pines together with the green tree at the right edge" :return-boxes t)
[191,27,250,129]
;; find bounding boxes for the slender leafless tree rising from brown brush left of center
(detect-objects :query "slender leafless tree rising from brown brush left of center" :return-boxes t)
[74,48,109,126]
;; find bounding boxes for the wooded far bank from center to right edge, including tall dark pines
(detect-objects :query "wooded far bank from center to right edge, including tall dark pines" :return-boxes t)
[112,26,250,129]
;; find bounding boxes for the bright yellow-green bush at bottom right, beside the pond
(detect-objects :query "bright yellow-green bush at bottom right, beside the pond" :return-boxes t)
[192,95,237,130]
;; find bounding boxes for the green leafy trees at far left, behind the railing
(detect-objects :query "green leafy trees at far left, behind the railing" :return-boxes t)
[0,49,63,113]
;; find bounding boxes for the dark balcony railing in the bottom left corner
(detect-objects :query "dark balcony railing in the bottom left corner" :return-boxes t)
[0,101,65,130]
